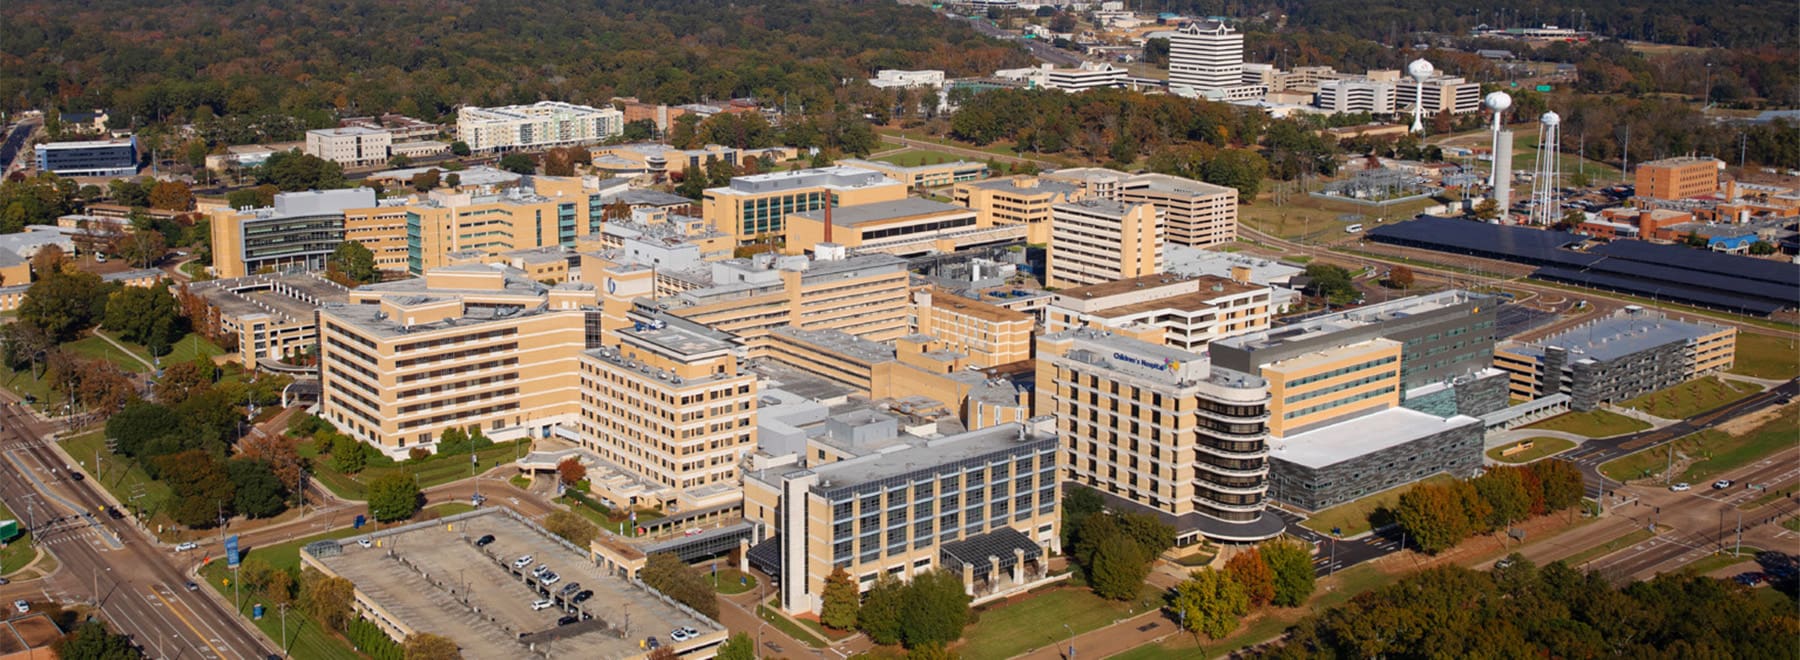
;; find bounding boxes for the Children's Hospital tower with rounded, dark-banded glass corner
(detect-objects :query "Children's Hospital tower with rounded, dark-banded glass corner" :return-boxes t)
[1033,329,1283,545]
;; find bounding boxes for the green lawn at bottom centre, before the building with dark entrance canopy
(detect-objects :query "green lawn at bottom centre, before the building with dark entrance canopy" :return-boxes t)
[956,584,1163,658]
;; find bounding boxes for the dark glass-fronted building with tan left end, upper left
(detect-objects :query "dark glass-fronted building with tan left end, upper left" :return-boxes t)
[211,187,374,277]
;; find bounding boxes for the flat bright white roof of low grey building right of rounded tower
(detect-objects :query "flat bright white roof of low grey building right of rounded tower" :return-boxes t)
[1269,408,1481,469]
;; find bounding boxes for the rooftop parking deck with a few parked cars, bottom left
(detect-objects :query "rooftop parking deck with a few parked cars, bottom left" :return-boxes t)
[301,507,727,660]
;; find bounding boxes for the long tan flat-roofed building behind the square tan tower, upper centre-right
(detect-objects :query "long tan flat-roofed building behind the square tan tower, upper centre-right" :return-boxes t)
[1042,167,1237,248]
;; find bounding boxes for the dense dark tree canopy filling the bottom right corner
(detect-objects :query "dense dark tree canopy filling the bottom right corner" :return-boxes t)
[1260,559,1800,658]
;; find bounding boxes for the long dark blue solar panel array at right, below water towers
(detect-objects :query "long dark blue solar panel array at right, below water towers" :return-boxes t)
[1368,216,1800,317]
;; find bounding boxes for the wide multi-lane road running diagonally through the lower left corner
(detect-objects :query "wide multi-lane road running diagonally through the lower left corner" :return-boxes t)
[0,403,274,658]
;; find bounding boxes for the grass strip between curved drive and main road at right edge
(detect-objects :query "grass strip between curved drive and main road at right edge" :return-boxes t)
[1600,415,1800,484]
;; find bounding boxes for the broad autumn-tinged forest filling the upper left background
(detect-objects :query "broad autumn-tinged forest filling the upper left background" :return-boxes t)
[0,0,1030,126]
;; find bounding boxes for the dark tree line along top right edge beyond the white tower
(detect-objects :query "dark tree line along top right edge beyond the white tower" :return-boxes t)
[1129,0,1800,52]
